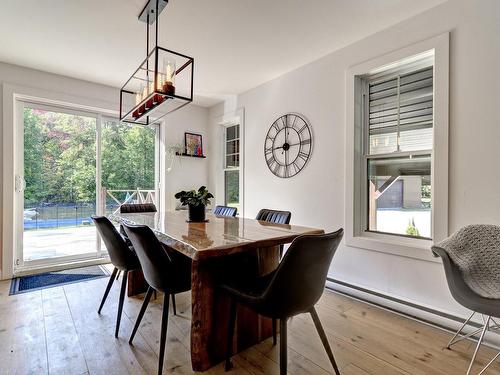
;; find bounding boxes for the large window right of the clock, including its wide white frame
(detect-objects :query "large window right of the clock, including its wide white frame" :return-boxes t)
[345,33,450,262]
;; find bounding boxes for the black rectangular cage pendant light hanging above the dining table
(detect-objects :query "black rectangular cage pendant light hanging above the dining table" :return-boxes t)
[120,0,194,125]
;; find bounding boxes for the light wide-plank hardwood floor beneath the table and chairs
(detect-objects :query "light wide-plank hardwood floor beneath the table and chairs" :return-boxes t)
[0,279,500,375]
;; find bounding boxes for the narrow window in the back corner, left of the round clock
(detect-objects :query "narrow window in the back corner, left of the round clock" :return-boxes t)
[223,125,240,211]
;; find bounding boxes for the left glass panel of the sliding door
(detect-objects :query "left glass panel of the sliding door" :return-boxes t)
[21,104,99,264]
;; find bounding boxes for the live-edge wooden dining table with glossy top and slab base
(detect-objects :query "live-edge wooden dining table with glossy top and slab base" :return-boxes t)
[110,211,323,371]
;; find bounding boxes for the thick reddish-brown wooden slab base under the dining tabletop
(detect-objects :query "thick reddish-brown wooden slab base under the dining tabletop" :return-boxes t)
[191,246,279,371]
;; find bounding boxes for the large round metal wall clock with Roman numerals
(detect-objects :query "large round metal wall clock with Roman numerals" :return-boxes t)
[264,113,312,178]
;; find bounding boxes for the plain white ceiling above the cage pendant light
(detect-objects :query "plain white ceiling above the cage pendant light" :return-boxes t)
[0,0,444,105]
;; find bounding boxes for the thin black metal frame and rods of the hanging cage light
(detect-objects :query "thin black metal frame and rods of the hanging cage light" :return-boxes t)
[120,0,194,125]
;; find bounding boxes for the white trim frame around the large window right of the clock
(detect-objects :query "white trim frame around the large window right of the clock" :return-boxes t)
[345,33,449,261]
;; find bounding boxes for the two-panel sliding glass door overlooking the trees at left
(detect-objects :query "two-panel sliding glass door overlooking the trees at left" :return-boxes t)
[15,102,158,271]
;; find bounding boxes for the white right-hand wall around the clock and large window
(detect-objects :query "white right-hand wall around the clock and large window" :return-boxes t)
[209,0,500,322]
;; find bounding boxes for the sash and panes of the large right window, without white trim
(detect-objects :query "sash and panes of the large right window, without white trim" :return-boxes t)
[360,57,434,239]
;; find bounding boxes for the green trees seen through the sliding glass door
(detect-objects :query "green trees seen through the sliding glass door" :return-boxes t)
[24,108,155,207]
